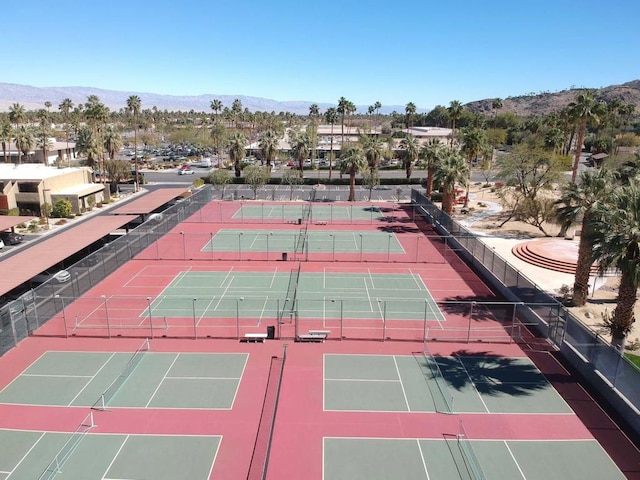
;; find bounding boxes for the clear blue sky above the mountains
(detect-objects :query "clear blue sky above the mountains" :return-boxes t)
[6,0,640,108]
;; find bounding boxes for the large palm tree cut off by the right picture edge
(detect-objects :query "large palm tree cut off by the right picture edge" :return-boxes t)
[587,178,640,352]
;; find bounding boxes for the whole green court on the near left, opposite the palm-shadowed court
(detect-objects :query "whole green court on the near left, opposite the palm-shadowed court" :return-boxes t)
[0,352,248,409]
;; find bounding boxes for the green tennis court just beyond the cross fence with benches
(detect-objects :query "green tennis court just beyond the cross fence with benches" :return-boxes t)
[150,268,444,321]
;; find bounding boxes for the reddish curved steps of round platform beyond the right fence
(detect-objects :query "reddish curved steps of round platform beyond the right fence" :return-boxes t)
[511,239,598,275]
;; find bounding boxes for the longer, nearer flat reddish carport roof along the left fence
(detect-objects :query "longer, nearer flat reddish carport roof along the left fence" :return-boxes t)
[0,215,136,295]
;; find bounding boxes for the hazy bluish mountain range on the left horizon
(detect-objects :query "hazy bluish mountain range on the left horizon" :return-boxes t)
[0,83,404,115]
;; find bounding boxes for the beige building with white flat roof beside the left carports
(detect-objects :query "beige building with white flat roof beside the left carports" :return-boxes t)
[0,163,104,216]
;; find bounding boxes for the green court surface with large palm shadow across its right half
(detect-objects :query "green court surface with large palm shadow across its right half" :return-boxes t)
[324,354,572,414]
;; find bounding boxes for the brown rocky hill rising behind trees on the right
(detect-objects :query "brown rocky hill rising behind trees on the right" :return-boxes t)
[465,80,640,116]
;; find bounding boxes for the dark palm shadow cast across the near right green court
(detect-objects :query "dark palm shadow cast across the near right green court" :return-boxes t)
[433,349,550,396]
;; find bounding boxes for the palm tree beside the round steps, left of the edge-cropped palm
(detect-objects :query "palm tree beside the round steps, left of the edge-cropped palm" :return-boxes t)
[556,168,612,307]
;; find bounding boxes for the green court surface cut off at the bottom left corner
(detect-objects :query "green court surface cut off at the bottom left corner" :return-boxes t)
[0,430,221,480]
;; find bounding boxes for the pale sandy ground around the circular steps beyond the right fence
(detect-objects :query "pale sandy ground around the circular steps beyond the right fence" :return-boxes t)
[455,185,640,353]
